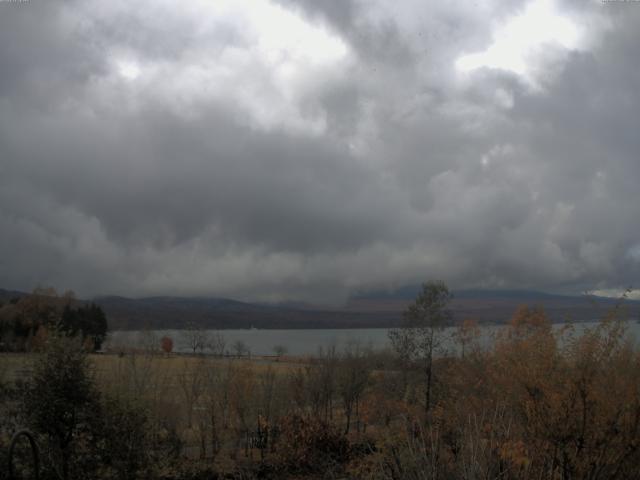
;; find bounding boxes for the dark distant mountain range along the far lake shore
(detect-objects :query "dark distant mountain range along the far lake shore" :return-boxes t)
[0,287,640,330]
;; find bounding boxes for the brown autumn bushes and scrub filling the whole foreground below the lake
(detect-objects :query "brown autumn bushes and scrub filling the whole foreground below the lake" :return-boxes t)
[0,302,640,480]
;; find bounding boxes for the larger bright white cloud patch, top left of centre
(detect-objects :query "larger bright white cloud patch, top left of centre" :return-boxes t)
[101,0,349,134]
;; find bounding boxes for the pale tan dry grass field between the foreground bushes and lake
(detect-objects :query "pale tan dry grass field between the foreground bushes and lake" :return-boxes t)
[0,352,306,463]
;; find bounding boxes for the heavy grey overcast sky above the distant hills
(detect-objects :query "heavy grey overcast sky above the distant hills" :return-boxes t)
[0,0,640,302]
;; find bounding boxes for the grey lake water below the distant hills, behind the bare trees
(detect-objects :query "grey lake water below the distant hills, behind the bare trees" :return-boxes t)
[105,321,640,355]
